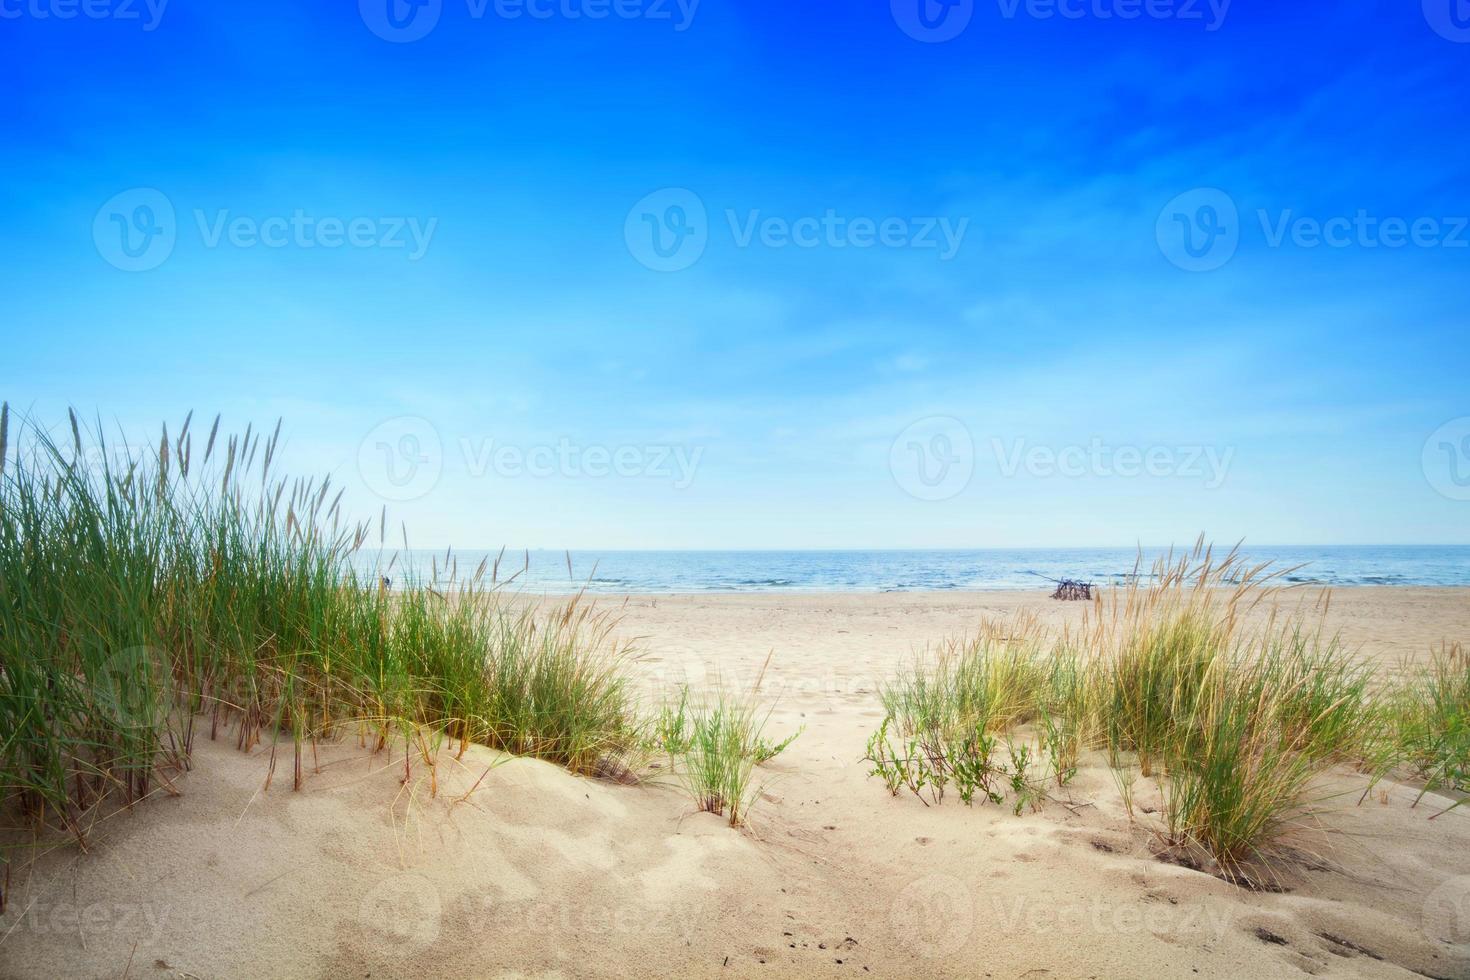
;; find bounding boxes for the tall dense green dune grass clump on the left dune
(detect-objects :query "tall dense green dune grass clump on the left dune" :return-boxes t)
[0,410,638,842]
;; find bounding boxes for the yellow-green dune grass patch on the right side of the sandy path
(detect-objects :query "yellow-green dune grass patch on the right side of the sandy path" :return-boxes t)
[869,541,1452,880]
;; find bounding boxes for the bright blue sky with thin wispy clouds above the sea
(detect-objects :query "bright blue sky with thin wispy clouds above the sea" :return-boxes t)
[0,0,1470,548]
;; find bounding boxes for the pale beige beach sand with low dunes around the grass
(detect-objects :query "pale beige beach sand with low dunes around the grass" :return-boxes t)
[0,588,1470,980]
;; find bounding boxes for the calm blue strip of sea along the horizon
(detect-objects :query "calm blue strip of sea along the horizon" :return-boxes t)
[359,545,1470,594]
